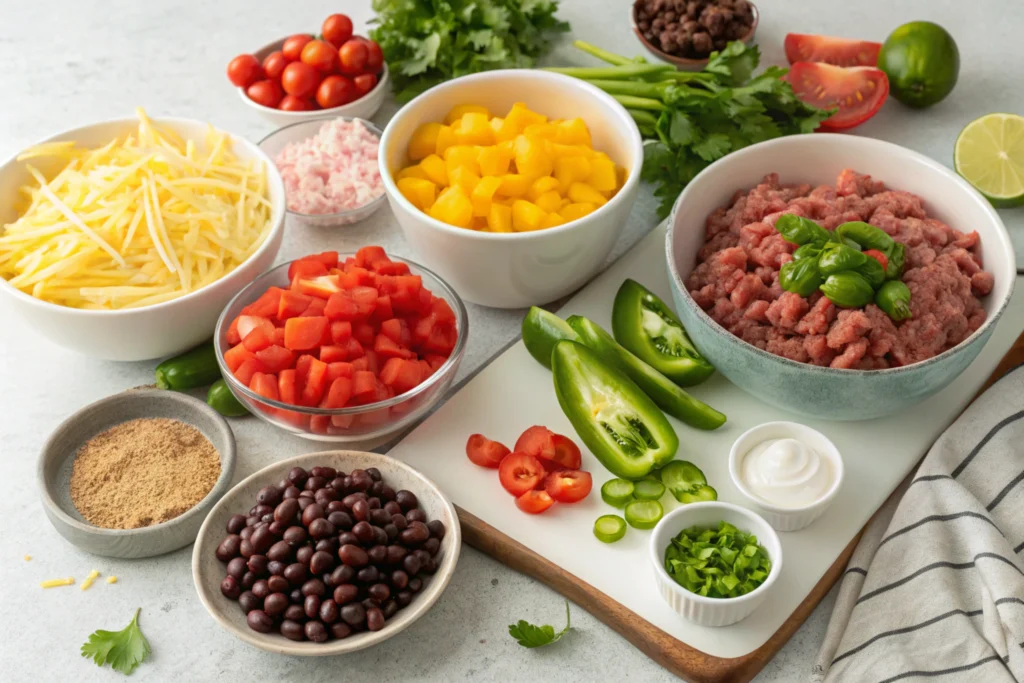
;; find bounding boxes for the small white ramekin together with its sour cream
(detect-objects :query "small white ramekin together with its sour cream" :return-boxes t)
[729,422,843,531]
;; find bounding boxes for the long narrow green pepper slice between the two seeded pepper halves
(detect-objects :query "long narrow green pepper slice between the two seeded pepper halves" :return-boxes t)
[567,315,725,429]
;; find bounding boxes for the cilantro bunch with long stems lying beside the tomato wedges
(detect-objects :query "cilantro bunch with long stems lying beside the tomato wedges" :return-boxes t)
[549,41,833,217]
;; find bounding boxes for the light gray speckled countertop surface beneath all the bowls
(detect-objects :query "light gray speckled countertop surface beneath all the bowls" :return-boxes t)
[0,0,1024,683]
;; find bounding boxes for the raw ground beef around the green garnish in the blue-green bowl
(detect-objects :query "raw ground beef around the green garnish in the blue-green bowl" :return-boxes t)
[686,174,994,370]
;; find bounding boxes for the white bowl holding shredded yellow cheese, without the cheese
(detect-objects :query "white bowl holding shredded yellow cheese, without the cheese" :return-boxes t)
[0,118,285,360]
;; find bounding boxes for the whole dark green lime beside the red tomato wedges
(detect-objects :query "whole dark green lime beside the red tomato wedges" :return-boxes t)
[879,22,959,109]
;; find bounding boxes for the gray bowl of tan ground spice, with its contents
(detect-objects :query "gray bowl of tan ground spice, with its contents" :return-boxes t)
[38,389,236,558]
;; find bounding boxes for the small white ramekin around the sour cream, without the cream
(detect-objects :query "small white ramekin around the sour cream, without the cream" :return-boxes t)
[729,422,844,531]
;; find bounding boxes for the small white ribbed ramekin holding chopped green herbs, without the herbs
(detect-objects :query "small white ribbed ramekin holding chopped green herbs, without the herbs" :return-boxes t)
[650,501,782,626]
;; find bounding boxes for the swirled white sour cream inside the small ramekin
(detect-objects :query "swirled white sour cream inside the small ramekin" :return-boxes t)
[739,438,836,508]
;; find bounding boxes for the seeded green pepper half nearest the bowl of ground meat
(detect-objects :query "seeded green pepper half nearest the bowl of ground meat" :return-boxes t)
[611,280,715,386]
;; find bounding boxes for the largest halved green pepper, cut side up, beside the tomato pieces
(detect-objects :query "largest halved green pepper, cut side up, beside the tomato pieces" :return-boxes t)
[551,340,679,480]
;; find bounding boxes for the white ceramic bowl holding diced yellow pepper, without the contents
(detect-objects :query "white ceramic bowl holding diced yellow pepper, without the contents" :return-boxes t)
[380,70,643,308]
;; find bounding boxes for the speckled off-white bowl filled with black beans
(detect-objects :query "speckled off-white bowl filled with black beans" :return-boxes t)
[193,451,462,656]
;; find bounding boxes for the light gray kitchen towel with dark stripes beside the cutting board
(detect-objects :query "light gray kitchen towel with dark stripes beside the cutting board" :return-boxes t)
[811,366,1024,683]
